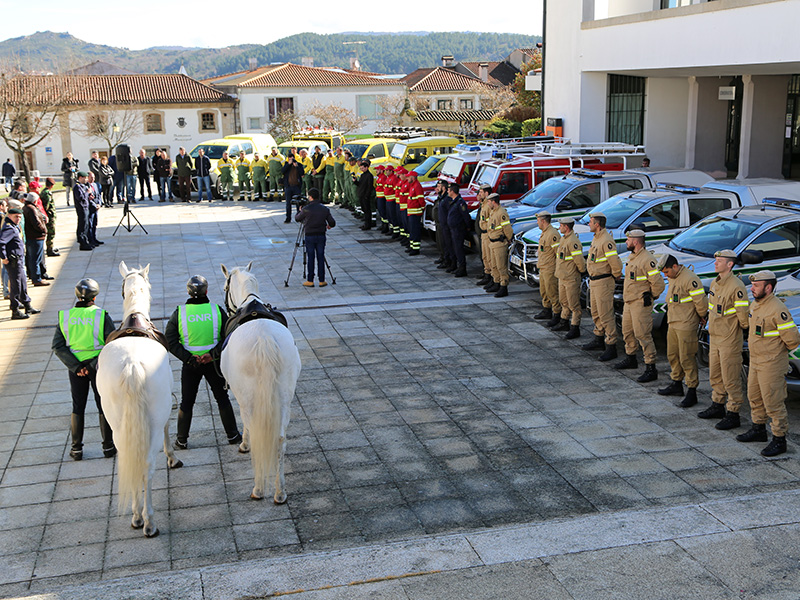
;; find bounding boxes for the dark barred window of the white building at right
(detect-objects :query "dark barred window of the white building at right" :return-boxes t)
[606,75,646,144]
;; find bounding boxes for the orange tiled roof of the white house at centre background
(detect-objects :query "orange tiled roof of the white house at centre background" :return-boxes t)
[206,63,403,88]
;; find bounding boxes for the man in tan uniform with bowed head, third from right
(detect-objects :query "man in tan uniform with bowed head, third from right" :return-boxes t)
[658,254,708,404]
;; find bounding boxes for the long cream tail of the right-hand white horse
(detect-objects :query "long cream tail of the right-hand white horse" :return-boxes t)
[245,334,283,494]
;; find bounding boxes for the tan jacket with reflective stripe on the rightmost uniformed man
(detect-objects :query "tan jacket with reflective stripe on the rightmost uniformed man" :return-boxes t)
[747,294,800,373]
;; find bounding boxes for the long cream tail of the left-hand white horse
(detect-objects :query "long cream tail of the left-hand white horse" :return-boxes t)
[114,361,150,510]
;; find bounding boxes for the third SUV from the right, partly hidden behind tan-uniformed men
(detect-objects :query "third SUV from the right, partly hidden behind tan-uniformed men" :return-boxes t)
[508,183,736,285]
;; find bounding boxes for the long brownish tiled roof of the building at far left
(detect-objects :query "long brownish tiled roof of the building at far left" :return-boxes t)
[0,74,234,106]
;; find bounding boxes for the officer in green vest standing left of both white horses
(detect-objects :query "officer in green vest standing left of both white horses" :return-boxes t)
[52,279,117,460]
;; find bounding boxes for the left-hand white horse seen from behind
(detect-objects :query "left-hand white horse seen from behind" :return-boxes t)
[97,262,183,537]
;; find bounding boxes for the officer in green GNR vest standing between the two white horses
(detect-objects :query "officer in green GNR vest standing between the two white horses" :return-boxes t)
[164,275,242,450]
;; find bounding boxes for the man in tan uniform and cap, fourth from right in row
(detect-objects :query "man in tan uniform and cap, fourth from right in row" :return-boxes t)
[614,229,666,383]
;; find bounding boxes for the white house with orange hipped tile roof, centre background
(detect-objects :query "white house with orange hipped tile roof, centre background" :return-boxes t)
[203,63,406,133]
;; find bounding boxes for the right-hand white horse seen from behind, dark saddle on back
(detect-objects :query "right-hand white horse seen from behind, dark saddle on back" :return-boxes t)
[220,262,301,504]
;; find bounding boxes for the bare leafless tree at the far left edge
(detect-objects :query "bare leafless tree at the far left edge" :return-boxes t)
[0,67,71,181]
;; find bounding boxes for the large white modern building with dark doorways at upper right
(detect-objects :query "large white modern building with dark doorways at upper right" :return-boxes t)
[544,0,800,179]
